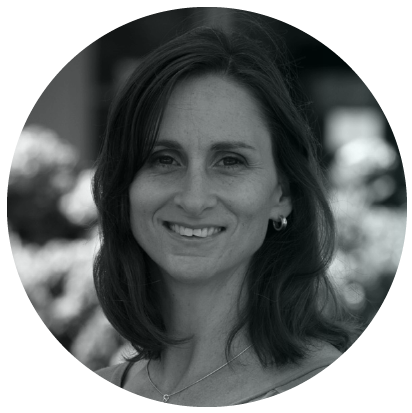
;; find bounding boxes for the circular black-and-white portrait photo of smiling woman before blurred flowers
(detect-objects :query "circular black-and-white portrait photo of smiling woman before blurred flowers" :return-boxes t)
[8,8,406,407]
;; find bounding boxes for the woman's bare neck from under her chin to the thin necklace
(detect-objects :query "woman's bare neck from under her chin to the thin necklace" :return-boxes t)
[150,264,249,392]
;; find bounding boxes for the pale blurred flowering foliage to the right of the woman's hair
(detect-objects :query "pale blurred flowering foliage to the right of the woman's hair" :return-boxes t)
[329,127,406,326]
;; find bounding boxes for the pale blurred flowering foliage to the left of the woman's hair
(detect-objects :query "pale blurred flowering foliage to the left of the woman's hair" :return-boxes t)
[7,126,124,370]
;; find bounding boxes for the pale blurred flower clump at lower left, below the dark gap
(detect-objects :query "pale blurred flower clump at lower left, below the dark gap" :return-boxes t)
[10,229,99,322]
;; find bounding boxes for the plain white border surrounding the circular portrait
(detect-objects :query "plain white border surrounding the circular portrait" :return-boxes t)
[0,0,412,412]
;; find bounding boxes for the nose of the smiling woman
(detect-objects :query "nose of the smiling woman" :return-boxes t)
[174,166,217,216]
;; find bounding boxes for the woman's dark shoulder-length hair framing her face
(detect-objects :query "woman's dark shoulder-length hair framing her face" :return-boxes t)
[93,23,353,366]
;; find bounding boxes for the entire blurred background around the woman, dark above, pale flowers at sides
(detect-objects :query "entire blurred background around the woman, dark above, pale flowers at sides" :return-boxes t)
[7,8,406,370]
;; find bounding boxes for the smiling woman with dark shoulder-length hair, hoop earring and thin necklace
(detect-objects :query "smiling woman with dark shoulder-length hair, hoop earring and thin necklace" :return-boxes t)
[93,24,358,406]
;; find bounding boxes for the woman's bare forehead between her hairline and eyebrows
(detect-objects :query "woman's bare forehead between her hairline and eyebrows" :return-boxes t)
[159,75,270,149]
